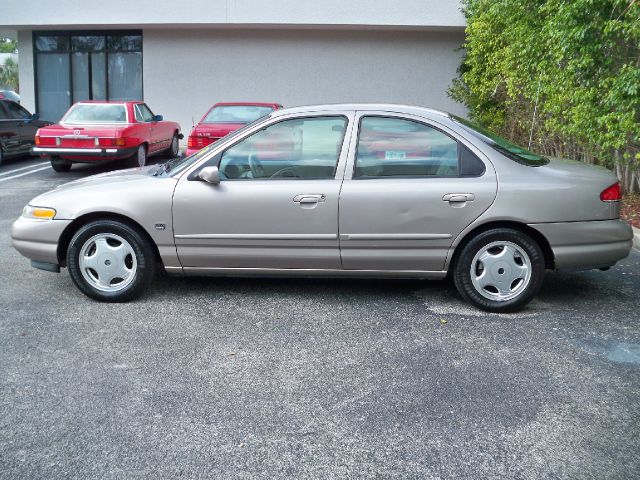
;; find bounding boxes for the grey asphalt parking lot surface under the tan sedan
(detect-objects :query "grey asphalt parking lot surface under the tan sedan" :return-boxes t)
[0,159,640,479]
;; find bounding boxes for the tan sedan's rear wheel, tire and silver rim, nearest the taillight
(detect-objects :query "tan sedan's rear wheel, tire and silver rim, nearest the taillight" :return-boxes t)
[453,228,545,312]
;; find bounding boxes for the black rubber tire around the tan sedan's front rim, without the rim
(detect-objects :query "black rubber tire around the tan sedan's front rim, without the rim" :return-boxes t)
[67,220,157,302]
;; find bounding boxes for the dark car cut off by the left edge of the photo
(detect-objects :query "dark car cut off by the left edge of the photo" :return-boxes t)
[0,99,51,163]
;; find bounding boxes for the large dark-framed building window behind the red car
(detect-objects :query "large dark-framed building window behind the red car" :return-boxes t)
[33,31,143,121]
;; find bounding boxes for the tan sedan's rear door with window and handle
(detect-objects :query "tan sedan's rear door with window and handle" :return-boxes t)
[339,112,497,271]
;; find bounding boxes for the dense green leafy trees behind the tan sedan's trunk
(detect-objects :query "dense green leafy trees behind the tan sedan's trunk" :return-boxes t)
[449,0,640,191]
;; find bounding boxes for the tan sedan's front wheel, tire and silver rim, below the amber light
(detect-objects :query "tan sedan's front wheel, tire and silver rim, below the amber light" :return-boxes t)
[67,220,155,302]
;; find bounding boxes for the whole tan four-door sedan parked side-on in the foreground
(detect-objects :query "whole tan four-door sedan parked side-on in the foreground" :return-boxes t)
[12,105,632,311]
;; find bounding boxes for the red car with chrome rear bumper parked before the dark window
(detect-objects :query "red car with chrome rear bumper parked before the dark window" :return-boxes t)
[31,101,182,172]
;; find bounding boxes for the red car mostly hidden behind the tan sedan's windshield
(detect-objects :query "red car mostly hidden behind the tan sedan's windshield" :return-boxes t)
[186,102,282,155]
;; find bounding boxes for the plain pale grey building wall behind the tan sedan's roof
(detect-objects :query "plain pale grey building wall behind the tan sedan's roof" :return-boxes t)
[143,29,464,136]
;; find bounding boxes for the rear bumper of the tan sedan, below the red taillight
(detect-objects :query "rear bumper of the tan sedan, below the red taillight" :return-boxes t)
[529,220,633,270]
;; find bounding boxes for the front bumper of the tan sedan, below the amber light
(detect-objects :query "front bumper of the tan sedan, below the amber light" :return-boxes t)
[11,217,71,266]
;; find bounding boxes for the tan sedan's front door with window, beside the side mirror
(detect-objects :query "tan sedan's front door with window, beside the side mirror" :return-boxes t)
[173,112,353,269]
